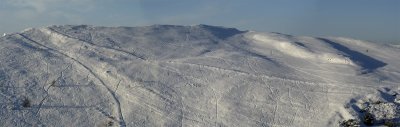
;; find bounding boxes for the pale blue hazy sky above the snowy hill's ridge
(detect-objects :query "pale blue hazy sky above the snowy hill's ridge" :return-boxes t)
[0,0,400,43]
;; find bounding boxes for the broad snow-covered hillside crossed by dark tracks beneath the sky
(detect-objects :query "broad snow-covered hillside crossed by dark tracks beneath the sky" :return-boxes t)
[0,25,400,127]
